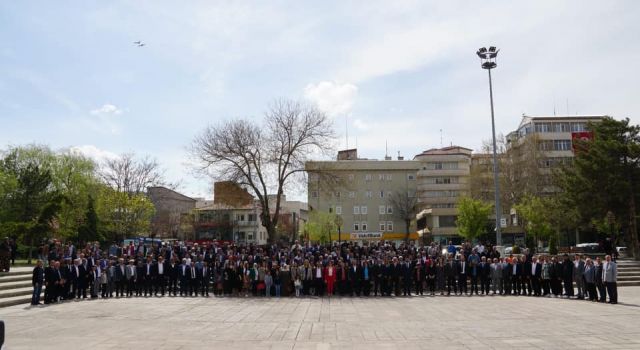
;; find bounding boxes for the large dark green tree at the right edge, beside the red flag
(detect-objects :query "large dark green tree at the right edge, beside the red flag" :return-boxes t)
[557,117,640,259]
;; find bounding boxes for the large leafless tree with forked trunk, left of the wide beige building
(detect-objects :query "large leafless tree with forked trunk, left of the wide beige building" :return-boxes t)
[191,100,334,242]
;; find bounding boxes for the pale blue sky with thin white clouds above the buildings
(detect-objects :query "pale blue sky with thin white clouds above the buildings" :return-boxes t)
[0,0,640,199]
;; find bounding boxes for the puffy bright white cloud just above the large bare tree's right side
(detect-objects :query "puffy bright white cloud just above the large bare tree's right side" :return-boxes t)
[304,81,358,116]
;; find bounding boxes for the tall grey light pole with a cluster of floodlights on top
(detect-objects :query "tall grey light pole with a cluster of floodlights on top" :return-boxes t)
[476,46,502,245]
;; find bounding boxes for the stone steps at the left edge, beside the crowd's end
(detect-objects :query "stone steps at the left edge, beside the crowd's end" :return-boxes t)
[0,267,39,307]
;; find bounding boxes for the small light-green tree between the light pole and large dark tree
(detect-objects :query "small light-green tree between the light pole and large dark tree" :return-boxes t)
[515,195,554,248]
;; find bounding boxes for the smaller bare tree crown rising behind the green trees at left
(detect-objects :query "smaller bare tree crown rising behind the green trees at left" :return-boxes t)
[100,153,175,195]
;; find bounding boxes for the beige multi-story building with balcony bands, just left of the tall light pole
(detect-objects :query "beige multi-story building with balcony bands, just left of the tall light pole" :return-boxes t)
[413,146,471,242]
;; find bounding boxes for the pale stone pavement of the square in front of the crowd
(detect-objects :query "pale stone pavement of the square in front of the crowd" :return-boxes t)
[0,287,640,350]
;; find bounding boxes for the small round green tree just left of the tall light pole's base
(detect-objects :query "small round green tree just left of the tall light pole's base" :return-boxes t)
[456,197,491,240]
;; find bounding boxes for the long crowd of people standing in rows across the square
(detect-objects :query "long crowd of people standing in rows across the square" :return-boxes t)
[32,241,617,305]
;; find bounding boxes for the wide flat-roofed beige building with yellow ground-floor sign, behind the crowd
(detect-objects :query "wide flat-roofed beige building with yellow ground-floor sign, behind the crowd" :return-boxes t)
[305,149,420,245]
